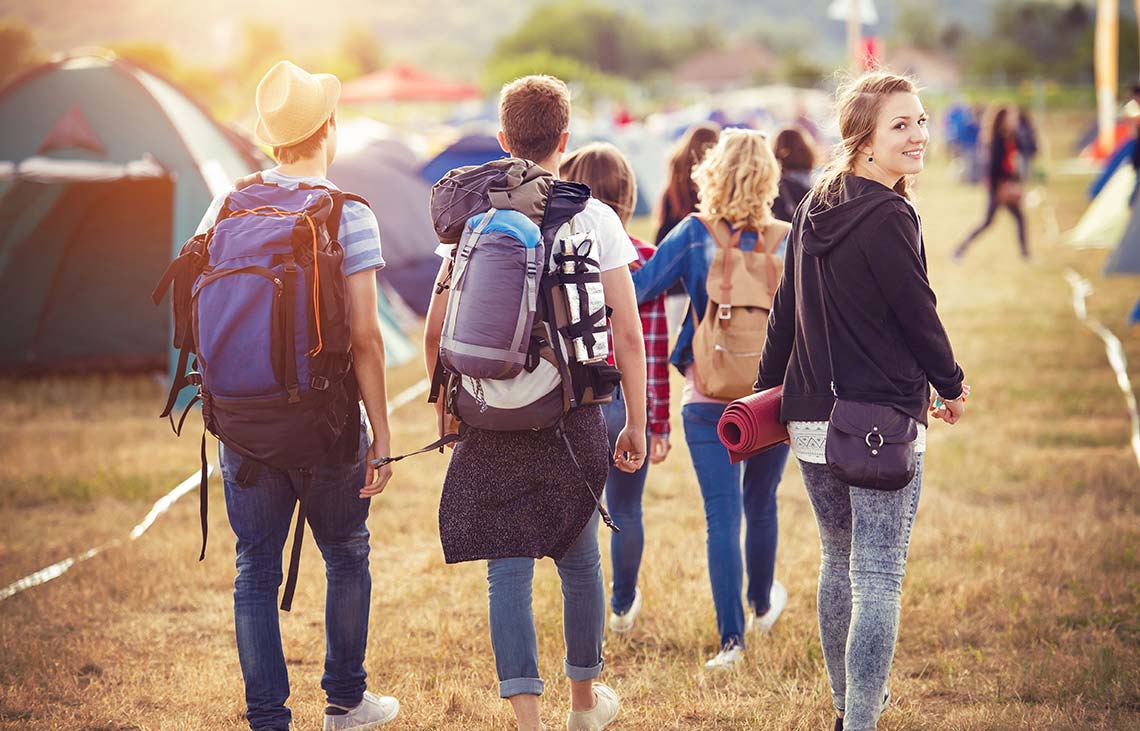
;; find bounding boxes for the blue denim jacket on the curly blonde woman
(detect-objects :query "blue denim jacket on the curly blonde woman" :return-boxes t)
[633,216,788,373]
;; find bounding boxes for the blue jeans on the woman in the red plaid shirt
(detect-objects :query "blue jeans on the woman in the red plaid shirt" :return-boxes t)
[602,398,649,615]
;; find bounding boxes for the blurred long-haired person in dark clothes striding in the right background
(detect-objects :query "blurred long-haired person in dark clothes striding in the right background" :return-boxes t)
[953,104,1029,260]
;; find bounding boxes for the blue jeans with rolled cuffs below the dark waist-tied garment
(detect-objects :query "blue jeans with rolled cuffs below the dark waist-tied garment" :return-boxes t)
[487,511,605,698]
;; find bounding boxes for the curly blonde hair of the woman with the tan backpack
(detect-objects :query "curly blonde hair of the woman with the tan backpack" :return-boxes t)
[693,129,780,230]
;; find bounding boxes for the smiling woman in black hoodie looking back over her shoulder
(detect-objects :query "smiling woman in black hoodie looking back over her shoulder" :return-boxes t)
[756,72,968,731]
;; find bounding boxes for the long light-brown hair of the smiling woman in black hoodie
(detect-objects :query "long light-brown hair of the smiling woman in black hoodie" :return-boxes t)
[812,71,919,205]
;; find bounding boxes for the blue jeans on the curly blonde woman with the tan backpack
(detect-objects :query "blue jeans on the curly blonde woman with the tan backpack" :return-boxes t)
[681,404,788,647]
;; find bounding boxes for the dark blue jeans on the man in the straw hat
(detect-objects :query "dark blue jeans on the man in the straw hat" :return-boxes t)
[219,433,372,731]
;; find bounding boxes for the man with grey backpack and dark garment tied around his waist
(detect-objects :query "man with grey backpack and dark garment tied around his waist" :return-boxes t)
[424,76,646,731]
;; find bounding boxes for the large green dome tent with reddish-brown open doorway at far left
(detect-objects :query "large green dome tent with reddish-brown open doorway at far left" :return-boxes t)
[0,54,415,373]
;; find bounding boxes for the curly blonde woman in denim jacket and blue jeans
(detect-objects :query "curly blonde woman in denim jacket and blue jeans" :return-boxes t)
[634,129,789,669]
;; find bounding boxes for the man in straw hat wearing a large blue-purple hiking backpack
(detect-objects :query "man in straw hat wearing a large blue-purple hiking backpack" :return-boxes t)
[156,60,399,731]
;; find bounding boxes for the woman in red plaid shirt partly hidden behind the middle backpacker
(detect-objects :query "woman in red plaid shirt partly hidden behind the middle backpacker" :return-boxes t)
[560,143,669,634]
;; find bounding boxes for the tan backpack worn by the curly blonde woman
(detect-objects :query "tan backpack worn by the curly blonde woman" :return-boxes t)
[693,217,783,401]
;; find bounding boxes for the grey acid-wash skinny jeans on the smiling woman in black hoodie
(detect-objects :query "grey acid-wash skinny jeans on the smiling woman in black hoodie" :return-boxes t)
[799,454,922,731]
